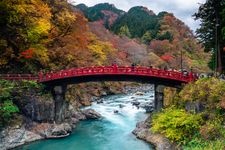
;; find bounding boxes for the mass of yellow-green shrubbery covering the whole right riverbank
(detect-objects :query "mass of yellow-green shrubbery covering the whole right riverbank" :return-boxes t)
[154,78,225,150]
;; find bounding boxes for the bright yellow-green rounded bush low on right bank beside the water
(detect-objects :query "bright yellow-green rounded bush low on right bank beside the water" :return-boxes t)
[151,107,202,142]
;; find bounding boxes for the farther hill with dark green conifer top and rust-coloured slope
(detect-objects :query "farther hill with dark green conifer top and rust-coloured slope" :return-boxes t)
[76,3,210,72]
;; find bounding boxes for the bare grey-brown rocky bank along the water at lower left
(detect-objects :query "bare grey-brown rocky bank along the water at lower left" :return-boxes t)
[0,109,101,150]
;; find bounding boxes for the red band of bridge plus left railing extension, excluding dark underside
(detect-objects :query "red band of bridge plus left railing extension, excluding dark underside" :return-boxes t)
[0,65,196,83]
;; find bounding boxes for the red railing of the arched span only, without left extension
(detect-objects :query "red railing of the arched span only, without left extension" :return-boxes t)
[39,65,196,82]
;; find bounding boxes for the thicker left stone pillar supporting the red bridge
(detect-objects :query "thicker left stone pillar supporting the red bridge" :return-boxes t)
[52,85,68,124]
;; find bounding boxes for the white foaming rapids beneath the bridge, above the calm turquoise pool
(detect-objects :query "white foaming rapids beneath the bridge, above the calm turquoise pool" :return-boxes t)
[88,93,152,127]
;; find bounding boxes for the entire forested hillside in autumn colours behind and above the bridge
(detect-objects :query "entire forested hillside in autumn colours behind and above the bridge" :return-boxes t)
[0,0,209,73]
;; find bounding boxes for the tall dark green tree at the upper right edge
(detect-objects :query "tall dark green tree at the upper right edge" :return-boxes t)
[194,0,225,72]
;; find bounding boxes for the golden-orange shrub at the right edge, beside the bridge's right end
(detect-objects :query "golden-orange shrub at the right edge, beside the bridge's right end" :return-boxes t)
[177,78,225,110]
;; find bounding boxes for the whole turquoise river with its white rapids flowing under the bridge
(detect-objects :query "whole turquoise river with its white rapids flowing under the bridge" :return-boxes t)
[19,93,155,150]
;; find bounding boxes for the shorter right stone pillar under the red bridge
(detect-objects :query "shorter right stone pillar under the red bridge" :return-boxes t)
[154,84,164,111]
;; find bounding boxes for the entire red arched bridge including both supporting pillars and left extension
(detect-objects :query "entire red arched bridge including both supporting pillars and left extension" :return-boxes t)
[0,65,197,123]
